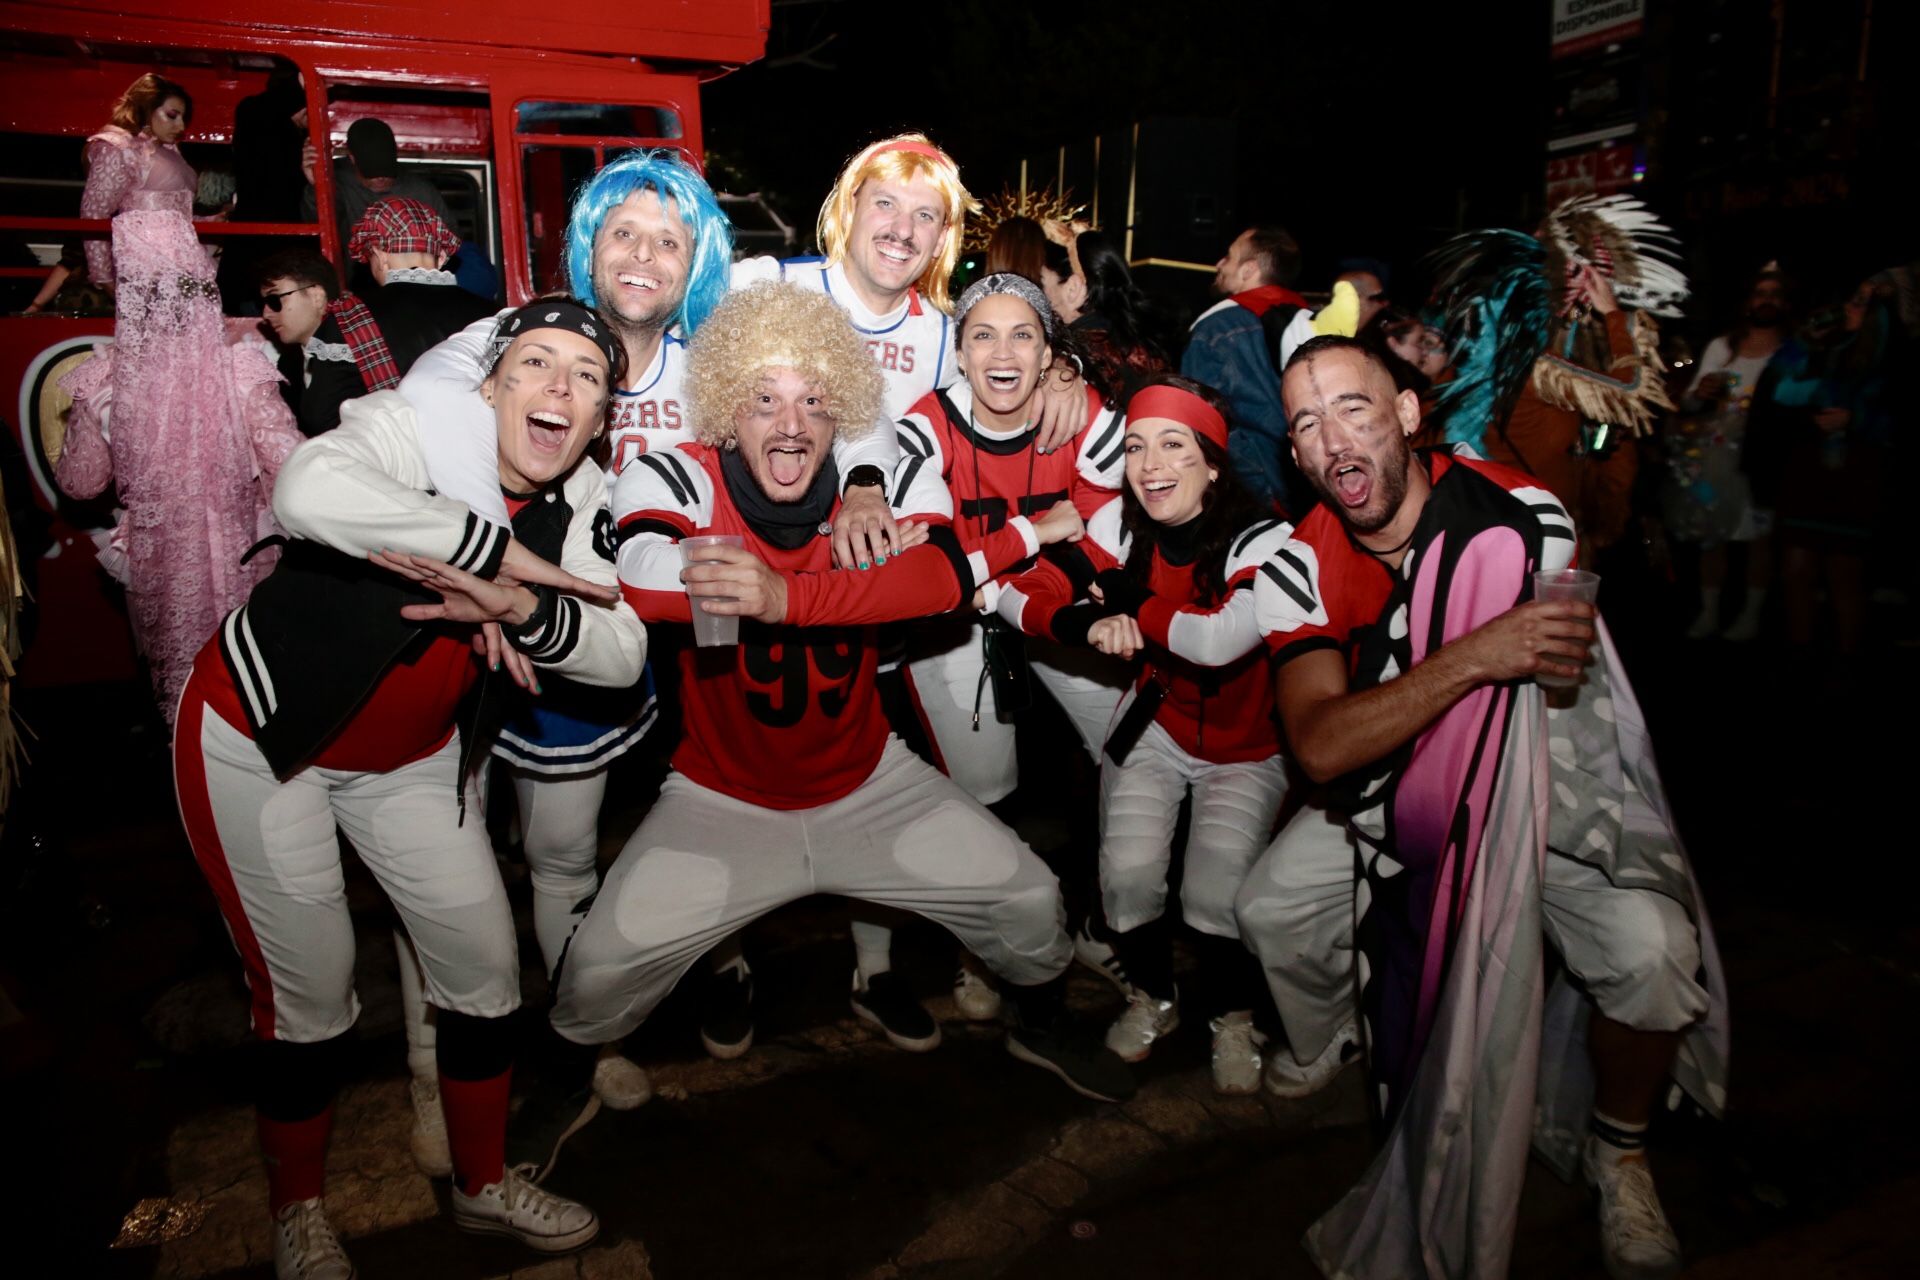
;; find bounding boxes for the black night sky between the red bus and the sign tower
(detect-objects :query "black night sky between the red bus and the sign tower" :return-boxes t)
[705,0,1548,295]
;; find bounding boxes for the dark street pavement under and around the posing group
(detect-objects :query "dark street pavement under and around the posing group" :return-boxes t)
[0,564,1920,1280]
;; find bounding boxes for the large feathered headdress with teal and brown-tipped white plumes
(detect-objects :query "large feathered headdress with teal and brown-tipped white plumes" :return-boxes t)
[1430,196,1688,451]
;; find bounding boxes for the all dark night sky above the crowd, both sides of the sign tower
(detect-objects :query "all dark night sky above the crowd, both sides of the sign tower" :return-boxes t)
[705,0,1920,337]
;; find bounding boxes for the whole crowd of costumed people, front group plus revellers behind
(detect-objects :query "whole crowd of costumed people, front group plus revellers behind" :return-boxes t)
[7,75,1916,1276]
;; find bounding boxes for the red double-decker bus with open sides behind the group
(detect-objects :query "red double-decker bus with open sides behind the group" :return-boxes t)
[0,0,770,683]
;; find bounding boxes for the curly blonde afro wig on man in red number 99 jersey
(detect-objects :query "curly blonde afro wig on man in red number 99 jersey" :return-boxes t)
[685,280,885,449]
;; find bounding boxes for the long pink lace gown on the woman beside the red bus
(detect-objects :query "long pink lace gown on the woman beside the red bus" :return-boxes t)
[56,127,301,725]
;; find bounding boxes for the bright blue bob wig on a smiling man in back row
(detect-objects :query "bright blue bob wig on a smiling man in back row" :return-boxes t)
[566,150,733,338]
